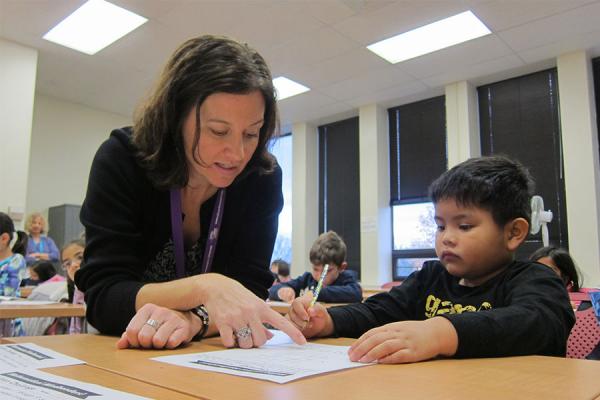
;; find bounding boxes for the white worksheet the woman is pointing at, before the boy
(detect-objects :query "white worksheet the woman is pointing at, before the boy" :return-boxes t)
[153,337,369,383]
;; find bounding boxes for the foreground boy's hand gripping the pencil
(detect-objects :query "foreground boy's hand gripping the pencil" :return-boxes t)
[287,291,333,338]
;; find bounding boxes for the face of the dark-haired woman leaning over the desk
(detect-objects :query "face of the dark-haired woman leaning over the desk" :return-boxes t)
[183,91,265,188]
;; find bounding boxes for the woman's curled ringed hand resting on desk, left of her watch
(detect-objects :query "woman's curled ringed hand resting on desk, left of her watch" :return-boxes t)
[117,304,196,349]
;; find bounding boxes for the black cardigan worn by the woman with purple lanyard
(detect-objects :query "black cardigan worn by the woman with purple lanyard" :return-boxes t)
[75,128,283,335]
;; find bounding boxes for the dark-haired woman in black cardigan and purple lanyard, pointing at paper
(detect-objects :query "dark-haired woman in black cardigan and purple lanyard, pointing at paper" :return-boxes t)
[75,36,305,348]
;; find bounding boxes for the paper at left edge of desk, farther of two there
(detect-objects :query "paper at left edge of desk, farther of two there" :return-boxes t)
[0,343,85,368]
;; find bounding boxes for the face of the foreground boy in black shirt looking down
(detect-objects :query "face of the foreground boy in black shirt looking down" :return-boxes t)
[435,199,512,286]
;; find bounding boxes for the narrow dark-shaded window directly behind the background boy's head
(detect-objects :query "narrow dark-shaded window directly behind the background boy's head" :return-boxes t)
[315,117,360,279]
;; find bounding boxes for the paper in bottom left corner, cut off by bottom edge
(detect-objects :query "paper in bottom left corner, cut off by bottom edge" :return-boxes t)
[0,366,146,400]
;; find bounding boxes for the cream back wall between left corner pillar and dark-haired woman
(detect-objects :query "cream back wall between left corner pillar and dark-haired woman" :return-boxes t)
[26,93,131,214]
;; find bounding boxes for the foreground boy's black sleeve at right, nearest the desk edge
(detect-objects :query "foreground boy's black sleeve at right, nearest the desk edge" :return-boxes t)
[442,263,575,358]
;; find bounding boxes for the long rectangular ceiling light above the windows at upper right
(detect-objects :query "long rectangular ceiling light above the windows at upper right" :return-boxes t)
[367,11,491,64]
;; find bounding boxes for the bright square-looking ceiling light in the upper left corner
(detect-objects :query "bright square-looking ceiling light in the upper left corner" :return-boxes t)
[44,0,148,55]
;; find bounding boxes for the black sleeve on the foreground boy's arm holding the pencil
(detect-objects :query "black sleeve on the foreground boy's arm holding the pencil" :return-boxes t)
[328,270,424,338]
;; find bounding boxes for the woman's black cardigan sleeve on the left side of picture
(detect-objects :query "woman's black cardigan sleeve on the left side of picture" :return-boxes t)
[75,136,149,335]
